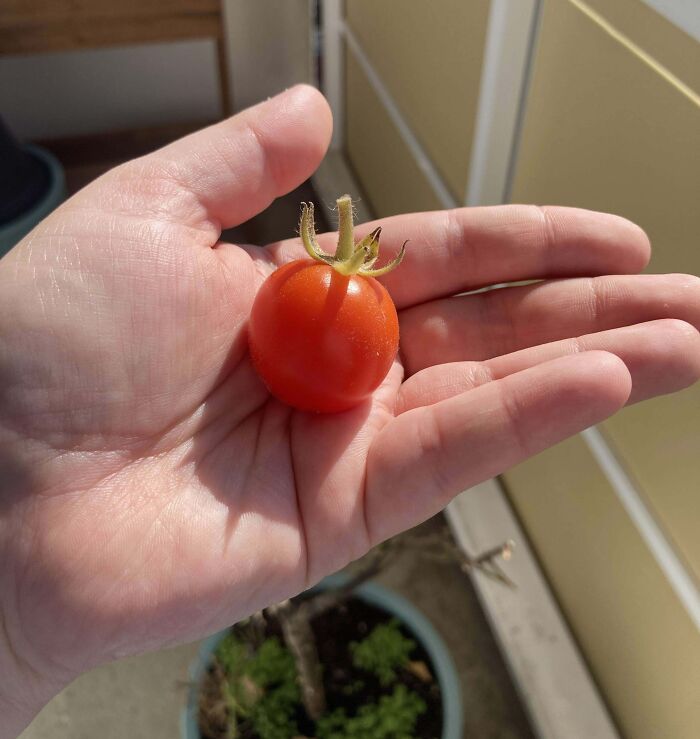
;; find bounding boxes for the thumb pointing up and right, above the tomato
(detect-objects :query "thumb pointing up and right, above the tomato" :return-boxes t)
[121,85,332,233]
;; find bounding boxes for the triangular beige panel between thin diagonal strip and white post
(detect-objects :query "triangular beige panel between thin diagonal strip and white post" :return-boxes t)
[347,0,490,202]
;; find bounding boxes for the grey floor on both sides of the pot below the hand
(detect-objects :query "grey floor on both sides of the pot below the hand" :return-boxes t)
[21,520,532,739]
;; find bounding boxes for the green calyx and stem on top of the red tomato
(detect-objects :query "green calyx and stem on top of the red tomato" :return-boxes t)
[299,195,408,277]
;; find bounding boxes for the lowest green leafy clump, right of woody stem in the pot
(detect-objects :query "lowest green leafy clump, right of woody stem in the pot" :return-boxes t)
[316,685,427,739]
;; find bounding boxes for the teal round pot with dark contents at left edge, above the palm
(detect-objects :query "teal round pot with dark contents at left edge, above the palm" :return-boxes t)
[0,118,64,256]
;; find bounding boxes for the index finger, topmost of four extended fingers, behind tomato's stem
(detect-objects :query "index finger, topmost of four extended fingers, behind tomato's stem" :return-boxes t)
[264,205,650,308]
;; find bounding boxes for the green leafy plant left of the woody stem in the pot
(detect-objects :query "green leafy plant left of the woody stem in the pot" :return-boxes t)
[216,633,301,739]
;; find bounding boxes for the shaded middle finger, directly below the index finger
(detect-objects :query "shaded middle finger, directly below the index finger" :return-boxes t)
[400,275,700,374]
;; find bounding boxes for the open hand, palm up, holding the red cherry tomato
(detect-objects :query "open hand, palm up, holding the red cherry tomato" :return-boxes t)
[0,87,700,732]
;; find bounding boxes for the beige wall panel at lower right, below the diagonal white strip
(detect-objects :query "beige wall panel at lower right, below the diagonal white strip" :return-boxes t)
[503,437,700,739]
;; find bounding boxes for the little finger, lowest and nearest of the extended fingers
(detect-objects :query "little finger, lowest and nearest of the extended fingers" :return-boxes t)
[365,352,631,542]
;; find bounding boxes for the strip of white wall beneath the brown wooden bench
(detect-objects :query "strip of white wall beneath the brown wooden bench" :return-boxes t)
[0,40,221,139]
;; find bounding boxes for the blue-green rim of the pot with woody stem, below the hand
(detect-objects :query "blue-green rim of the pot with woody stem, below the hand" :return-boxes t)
[181,575,462,739]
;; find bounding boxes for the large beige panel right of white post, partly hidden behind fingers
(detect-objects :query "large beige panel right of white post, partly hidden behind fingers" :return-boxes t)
[512,0,700,576]
